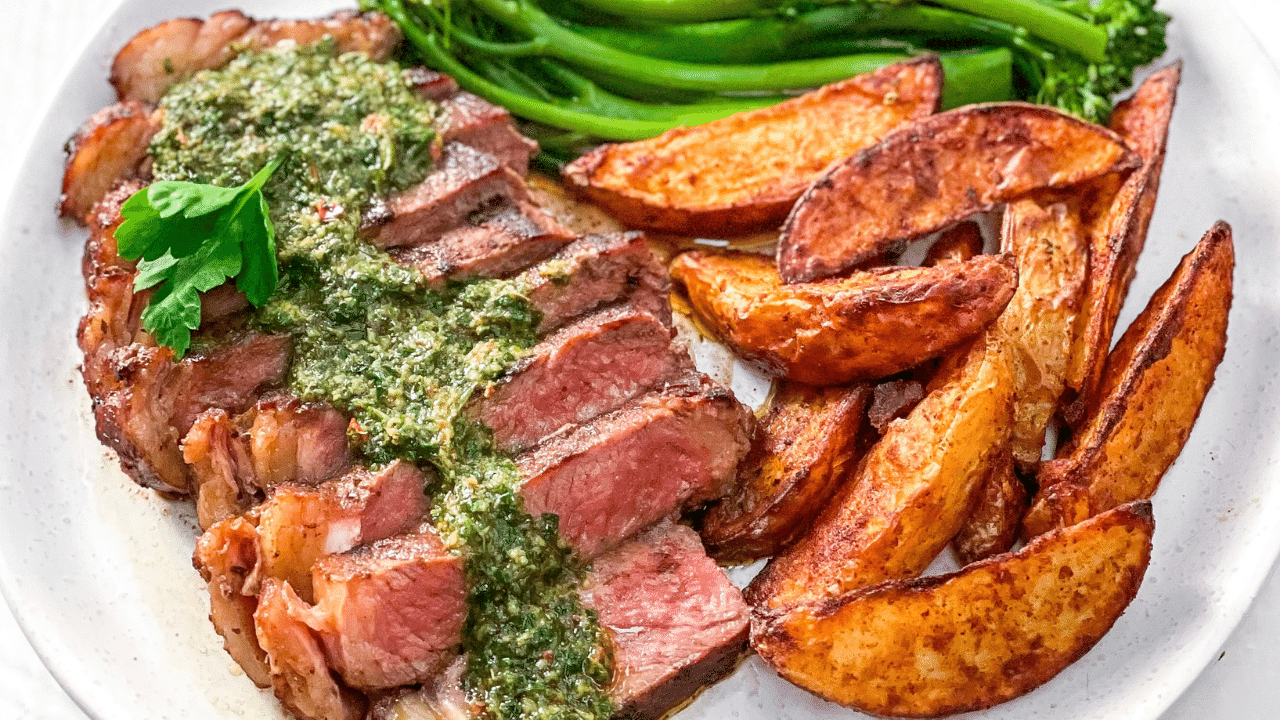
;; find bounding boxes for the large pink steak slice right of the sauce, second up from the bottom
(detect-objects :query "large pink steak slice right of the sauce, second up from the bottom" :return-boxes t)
[516,374,755,559]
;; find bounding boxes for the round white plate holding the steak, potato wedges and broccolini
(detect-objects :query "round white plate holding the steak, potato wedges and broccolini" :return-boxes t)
[0,0,1280,720]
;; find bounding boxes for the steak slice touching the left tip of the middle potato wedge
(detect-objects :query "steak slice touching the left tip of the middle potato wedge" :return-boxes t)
[521,233,671,334]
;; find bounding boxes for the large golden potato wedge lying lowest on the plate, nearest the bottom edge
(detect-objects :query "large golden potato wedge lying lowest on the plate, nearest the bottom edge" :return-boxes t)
[751,502,1155,717]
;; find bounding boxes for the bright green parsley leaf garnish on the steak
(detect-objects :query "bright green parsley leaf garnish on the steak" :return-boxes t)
[115,159,280,359]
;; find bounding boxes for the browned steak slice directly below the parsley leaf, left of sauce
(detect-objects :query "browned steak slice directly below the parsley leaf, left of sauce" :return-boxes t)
[84,333,289,493]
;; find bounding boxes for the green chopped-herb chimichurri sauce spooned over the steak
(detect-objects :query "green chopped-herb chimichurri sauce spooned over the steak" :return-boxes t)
[151,44,613,720]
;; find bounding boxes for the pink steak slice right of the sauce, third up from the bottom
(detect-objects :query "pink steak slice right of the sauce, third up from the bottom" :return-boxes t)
[467,305,692,452]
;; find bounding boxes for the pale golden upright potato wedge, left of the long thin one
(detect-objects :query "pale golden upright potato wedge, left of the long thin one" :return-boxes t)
[996,200,1088,466]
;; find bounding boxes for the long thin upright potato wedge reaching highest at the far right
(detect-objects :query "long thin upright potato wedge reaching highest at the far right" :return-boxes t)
[1062,64,1181,428]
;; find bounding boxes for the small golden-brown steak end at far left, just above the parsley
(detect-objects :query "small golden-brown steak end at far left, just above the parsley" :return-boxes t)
[58,102,160,223]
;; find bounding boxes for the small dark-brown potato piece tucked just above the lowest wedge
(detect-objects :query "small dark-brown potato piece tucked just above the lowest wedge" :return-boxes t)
[951,447,1029,565]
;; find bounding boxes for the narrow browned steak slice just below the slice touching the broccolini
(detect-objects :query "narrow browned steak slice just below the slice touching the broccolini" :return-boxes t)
[361,142,529,249]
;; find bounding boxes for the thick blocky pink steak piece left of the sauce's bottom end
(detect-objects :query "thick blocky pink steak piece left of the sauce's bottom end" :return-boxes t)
[308,528,467,691]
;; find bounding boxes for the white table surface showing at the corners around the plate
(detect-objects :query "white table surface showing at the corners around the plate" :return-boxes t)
[0,0,1280,720]
